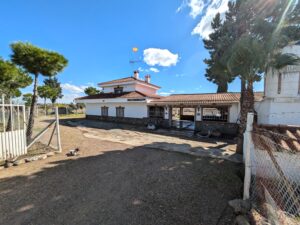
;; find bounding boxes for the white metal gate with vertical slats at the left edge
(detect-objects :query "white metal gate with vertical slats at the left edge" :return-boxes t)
[0,95,27,160]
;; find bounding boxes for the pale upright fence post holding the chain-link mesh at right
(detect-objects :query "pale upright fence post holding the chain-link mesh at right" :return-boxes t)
[243,113,254,200]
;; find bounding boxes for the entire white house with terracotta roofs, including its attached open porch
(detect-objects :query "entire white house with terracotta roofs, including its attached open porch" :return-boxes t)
[76,71,262,135]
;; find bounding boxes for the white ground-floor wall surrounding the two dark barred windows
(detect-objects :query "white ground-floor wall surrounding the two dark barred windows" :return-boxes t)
[85,102,148,118]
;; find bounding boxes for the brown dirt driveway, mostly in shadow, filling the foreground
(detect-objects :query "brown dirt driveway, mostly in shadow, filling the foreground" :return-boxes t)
[0,118,242,225]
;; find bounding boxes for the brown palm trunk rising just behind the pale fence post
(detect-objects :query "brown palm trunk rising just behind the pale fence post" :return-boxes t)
[236,80,254,154]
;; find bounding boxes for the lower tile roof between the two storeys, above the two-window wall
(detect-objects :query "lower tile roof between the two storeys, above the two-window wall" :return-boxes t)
[76,91,161,100]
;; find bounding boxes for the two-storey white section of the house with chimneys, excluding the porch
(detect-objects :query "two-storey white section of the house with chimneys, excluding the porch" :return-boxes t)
[76,71,163,123]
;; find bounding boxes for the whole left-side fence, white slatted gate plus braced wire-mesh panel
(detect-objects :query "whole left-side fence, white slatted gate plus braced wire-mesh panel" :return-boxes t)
[0,95,61,163]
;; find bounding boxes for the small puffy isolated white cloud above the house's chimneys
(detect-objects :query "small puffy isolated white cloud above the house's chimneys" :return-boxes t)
[144,48,179,67]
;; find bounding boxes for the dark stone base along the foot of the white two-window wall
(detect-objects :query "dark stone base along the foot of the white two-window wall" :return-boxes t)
[86,115,168,128]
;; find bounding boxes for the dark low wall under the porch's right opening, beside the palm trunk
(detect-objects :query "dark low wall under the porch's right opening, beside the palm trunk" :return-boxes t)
[195,121,238,136]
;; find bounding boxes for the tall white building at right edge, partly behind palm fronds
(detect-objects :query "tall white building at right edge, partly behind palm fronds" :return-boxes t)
[256,44,300,126]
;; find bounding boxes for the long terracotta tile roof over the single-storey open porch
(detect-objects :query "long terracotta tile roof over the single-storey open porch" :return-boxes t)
[151,92,263,104]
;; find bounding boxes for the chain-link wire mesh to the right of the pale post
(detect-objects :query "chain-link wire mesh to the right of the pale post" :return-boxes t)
[250,127,300,225]
